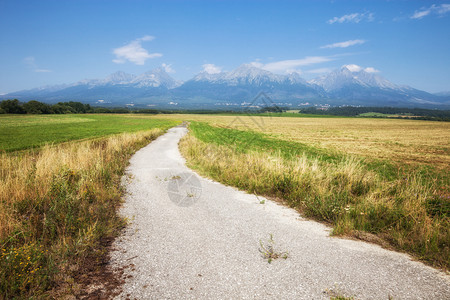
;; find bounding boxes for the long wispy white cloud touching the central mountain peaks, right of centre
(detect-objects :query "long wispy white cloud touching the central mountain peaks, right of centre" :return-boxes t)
[251,56,335,73]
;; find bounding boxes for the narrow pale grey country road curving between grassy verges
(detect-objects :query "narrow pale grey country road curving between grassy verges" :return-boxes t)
[111,127,450,299]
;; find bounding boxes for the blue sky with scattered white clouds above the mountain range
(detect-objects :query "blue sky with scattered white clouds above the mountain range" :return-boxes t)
[0,0,450,94]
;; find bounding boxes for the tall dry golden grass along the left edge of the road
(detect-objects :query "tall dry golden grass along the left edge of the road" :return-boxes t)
[0,129,163,299]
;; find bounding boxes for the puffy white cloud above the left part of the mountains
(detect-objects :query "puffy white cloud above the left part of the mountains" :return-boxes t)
[113,35,162,65]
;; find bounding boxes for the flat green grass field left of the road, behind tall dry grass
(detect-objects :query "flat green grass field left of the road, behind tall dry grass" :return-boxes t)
[0,114,177,152]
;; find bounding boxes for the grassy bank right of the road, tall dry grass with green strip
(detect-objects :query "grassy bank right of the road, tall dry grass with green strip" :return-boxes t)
[180,122,450,269]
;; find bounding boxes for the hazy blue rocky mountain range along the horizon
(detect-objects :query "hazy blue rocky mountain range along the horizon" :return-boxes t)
[1,64,450,109]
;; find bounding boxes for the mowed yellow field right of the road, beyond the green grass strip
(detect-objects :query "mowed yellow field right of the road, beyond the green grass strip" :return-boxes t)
[160,115,450,169]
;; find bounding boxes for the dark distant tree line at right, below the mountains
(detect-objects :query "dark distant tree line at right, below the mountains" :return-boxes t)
[299,106,450,121]
